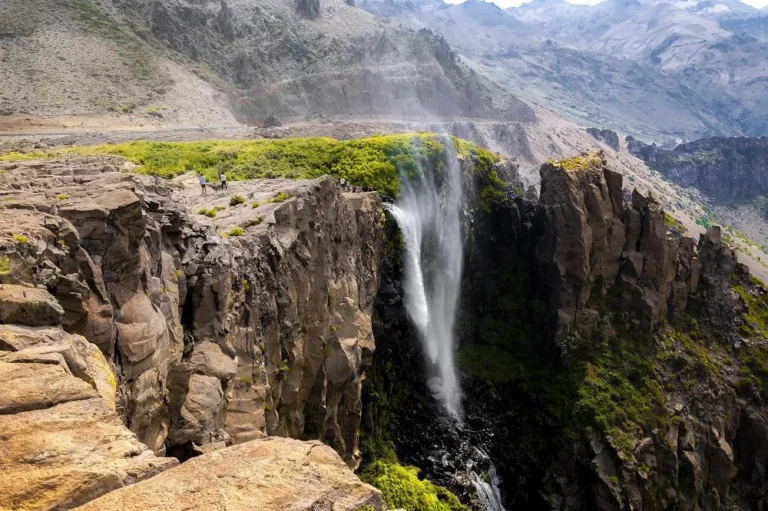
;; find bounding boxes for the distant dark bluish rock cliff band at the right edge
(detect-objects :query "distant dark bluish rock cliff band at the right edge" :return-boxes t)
[627,137,768,202]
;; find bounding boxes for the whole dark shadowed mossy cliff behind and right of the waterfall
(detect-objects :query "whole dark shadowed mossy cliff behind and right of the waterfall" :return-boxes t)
[364,150,768,510]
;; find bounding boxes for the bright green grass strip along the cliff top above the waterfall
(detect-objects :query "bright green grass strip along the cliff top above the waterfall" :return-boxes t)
[0,133,504,199]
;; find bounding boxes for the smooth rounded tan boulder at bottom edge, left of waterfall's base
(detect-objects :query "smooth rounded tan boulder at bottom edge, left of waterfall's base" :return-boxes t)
[79,437,387,511]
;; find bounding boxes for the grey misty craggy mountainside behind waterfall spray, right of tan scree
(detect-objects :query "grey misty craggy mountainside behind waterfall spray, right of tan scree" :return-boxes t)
[107,0,536,124]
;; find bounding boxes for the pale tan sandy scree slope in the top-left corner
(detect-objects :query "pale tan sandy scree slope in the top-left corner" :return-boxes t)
[0,0,234,124]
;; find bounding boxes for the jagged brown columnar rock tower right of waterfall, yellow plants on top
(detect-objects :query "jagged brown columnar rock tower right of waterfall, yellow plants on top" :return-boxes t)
[538,154,701,352]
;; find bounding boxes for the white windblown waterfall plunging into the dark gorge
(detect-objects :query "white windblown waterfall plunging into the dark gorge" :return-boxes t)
[388,137,463,421]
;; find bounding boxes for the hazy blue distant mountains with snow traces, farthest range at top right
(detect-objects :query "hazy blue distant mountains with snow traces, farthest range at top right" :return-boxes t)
[362,0,768,140]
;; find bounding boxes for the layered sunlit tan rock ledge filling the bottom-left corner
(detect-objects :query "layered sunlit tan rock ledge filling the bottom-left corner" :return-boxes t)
[0,285,178,509]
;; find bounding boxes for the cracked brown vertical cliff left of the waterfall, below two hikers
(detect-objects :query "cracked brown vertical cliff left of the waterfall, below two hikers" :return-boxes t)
[0,160,382,465]
